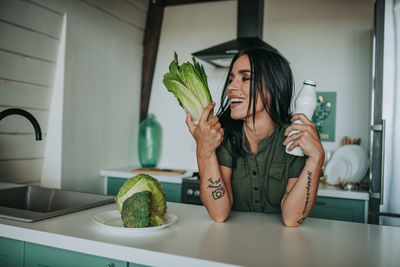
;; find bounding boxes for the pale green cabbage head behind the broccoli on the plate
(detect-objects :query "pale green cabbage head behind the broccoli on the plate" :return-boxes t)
[115,174,167,226]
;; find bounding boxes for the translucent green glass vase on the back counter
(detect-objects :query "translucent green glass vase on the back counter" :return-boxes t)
[138,114,162,168]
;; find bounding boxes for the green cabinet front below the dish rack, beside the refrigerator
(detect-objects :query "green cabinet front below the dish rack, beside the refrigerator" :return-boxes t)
[310,197,365,223]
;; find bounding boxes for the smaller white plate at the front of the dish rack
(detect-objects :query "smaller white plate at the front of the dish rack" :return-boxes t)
[325,158,351,185]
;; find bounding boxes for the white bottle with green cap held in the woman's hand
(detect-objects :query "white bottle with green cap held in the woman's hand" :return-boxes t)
[286,80,317,157]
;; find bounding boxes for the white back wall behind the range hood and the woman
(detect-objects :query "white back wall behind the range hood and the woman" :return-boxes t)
[149,0,374,172]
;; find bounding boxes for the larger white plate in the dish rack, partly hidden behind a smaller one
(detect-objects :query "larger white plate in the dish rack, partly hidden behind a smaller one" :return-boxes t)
[332,145,369,183]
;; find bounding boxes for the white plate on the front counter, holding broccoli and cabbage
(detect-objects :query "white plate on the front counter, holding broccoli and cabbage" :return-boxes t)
[92,210,178,233]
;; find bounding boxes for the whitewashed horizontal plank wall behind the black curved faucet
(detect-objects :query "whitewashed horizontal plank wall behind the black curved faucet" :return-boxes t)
[0,0,63,183]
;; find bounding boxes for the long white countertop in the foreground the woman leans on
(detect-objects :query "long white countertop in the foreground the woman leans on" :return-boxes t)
[0,202,400,267]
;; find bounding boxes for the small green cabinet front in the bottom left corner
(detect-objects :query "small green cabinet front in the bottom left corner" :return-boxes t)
[0,237,24,267]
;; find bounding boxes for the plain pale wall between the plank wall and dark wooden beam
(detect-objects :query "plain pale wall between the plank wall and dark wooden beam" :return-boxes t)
[31,0,147,193]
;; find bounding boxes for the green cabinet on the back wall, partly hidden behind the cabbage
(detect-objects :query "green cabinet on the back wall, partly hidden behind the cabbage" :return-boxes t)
[107,177,182,202]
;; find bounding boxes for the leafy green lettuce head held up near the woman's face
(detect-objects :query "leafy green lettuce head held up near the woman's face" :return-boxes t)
[163,53,213,122]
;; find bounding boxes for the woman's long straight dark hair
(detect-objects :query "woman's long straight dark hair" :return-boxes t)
[217,48,293,166]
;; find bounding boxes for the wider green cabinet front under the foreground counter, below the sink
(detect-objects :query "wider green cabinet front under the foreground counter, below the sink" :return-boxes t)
[24,242,128,267]
